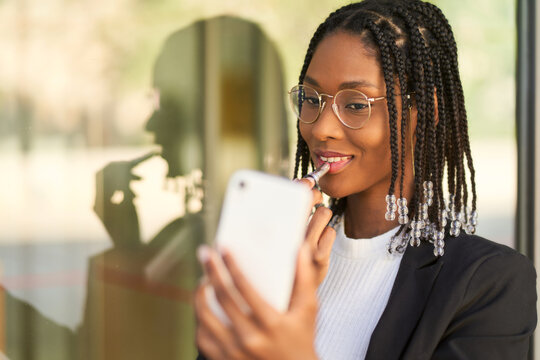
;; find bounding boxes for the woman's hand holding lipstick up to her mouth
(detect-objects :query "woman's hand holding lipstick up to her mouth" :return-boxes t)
[296,179,336,285]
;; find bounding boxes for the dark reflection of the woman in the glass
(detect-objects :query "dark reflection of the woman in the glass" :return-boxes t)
[2,16,288,360]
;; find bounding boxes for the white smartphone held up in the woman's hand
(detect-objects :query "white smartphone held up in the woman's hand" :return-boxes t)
[206,170,312,324]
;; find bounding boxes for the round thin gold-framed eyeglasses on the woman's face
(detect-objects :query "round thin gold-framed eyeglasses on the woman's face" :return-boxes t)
[289,85,386,129]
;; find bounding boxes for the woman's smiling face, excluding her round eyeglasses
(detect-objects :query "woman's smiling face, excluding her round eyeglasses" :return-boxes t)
[300,32,401,198]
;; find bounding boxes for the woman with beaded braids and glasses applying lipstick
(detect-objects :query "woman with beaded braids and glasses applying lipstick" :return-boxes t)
[196,0,536,360]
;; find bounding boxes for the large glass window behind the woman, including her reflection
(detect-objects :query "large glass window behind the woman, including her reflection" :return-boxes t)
[0,0,516,360]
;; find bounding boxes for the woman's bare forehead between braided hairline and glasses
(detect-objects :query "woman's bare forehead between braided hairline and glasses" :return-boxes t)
[306,32,384,92]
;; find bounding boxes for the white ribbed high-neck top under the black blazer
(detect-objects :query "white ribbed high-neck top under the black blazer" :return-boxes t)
[315,221,402,360]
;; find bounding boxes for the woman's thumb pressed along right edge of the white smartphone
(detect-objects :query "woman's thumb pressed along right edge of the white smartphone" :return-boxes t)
[289,242,317,310]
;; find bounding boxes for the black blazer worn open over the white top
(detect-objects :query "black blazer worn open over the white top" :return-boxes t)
[197,232,536,360]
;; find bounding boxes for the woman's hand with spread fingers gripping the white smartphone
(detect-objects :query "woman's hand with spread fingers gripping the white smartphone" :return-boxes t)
[195,245,317,360]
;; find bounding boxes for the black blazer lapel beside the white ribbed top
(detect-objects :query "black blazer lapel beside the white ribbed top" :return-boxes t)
[366,244,443,360]
